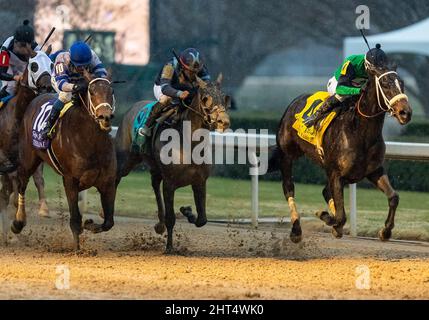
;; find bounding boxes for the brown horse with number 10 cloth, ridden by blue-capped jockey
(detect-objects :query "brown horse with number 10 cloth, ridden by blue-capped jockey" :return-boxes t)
[11,74,116,250]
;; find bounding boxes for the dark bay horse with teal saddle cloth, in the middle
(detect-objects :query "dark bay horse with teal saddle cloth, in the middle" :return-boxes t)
[115,77,230,253]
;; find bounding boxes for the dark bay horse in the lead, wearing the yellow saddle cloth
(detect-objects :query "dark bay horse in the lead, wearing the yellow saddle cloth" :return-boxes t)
[270,68,412,243]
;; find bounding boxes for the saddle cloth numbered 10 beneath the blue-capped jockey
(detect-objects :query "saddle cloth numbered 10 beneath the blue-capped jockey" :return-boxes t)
[31,99,73,150]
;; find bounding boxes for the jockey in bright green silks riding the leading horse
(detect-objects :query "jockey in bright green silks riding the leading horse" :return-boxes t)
[305,44,388,127]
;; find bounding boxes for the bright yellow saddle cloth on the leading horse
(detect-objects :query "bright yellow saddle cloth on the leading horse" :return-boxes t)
[292,91,337,159]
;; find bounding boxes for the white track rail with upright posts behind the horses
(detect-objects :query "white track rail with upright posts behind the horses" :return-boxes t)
[103,127,429,236]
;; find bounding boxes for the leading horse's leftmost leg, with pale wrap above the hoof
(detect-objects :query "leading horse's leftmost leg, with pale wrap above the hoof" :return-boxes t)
[280,157,302,243]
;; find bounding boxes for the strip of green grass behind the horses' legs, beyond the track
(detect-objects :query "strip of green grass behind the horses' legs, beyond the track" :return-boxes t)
[23,168,429,240]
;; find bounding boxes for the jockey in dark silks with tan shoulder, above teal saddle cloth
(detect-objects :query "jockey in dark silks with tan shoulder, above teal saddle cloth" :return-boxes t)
[140,48,210,136]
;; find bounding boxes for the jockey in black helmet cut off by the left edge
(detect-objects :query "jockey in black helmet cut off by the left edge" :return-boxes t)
[0,20,38,98]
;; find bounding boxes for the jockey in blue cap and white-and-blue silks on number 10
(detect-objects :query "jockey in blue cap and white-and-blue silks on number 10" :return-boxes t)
[42,41,107,138]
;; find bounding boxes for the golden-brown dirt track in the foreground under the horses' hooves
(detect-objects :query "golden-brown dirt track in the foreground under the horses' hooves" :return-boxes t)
[0,212,429,299]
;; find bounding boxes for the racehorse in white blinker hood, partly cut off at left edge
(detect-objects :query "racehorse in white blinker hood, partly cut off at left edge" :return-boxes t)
[0,51,52,242]
